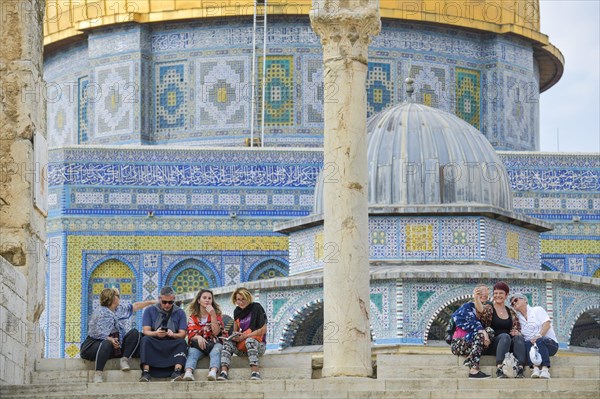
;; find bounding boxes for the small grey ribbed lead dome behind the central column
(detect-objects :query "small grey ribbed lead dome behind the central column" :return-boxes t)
[314,100,512,214]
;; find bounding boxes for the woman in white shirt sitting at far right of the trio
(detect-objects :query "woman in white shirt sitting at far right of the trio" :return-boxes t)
[510,293,558,379]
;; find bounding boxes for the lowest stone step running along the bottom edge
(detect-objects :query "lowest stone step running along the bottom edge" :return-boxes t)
[0,377,600,399]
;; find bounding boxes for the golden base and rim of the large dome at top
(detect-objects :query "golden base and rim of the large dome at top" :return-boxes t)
[44,0,564,91]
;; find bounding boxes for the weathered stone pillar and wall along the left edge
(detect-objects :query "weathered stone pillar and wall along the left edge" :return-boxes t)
[0,0,46,385]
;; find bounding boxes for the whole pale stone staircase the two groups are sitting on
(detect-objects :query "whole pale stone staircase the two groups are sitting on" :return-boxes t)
[0,346,600,399]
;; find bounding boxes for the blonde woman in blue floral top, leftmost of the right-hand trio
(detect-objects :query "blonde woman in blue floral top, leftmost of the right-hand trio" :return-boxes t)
[450,284,494,378]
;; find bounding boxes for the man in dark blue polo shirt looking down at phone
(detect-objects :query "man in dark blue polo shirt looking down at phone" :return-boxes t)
[140,287,187,382]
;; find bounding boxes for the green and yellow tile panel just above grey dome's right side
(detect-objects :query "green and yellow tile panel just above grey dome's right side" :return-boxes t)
[456,67,481,129]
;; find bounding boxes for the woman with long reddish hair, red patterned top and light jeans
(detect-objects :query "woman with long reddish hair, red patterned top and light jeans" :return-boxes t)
[183,289,226,381]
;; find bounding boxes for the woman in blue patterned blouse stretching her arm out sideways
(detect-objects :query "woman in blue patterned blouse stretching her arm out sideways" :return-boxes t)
[80,288,155,382]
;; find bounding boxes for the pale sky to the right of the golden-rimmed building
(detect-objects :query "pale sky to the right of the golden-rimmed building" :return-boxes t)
[540,0,600,153]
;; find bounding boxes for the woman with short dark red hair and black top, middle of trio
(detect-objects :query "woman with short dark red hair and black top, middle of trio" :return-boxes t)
[477,281,526,378]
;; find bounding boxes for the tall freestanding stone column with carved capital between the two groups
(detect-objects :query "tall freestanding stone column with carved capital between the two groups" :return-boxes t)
[310,0,381,377]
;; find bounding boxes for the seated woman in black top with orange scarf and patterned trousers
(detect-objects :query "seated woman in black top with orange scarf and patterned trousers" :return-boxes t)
[217,287,267,381]
